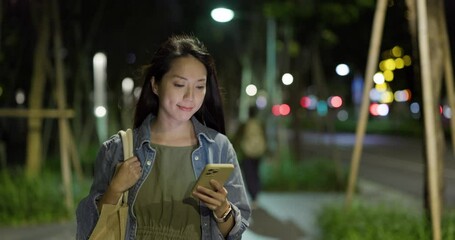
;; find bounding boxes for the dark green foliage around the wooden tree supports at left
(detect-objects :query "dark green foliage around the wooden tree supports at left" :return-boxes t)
[0,169,89,225]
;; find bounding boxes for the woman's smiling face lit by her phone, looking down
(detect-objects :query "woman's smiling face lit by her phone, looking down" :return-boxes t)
[152,56,207,124]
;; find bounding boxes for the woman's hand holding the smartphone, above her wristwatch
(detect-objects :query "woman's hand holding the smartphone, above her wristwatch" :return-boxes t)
[193,179,230,217]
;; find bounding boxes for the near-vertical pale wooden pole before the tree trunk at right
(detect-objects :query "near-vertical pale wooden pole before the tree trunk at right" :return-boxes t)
[417,0,441,240]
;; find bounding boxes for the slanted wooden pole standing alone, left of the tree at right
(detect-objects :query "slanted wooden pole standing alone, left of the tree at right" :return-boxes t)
[345,0,388,208]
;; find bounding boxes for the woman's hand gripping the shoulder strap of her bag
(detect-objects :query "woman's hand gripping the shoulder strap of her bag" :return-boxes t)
[109,156,142,193]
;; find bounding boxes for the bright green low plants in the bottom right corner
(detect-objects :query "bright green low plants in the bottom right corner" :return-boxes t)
[318,203,455,240]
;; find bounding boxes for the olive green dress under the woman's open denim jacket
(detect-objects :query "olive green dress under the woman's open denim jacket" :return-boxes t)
[134,144,201,240]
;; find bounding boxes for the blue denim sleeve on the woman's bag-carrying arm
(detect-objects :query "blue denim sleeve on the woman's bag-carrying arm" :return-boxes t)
[76,135,123,240]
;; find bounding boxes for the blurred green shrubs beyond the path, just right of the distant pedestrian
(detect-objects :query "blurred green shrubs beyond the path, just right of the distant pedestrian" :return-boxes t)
[260,146,347,191]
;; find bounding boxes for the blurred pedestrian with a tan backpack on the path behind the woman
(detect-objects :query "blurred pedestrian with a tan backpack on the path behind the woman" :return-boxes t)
[239,106,267,208]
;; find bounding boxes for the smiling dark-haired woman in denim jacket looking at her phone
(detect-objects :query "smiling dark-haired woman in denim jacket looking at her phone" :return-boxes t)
[76,35,251,239]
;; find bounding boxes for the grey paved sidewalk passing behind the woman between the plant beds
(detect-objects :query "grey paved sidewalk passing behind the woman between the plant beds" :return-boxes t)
[0,181,421,240]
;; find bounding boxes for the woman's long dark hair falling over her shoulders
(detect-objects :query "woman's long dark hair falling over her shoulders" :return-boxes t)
[134,35,226,134]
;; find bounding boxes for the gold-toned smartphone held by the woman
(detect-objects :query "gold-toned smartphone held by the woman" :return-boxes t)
[193,163,234,191]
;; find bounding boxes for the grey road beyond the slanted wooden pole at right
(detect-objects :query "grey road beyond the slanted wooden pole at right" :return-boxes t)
[294,132,455,207]
